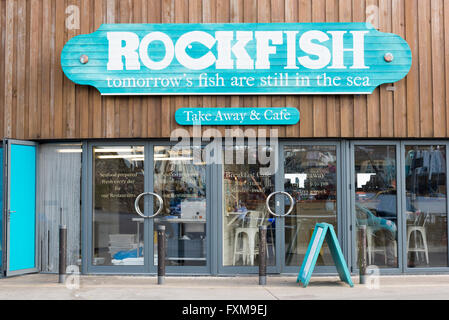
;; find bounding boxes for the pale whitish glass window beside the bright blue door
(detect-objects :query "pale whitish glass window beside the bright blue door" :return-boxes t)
[38,143,82,272]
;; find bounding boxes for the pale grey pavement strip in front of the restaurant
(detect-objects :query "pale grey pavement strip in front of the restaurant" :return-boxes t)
[0,274,449,300]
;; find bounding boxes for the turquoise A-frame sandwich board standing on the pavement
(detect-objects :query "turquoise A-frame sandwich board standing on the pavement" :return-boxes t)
[296,223,354,288]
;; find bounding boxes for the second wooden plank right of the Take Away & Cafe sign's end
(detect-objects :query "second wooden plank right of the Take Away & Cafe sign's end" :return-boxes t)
[312,0,327,137]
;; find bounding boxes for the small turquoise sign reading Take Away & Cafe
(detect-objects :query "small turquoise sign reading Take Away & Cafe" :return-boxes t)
[175,108,299,126]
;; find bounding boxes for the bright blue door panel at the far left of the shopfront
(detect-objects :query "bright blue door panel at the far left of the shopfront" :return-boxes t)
[5,140,37,276]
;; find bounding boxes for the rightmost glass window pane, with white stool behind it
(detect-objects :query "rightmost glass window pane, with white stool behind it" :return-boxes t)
[405,145,448,267]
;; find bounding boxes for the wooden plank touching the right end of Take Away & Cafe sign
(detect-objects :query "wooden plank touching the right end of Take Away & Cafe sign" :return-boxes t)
[298,0,313,137]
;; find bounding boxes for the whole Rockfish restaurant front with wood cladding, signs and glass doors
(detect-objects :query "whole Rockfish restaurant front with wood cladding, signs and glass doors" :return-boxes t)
[0,0,449,276]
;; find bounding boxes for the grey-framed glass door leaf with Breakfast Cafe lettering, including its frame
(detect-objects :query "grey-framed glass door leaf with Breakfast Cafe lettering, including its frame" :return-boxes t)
[218,143,280,274]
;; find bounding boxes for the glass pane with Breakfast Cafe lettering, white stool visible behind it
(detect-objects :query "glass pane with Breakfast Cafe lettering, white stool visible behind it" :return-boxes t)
[223,146,276,266]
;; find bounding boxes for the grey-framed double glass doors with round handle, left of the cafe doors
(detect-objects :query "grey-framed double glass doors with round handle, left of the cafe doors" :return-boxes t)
[87,142,210,274]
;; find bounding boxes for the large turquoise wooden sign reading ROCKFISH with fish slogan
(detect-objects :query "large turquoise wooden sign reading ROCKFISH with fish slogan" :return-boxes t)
[61,23,412,95]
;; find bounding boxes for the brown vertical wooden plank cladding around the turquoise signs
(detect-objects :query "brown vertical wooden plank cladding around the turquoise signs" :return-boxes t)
[0,0,449,140]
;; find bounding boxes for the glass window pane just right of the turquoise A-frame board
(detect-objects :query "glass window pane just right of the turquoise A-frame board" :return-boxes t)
[354,145,398,268]
